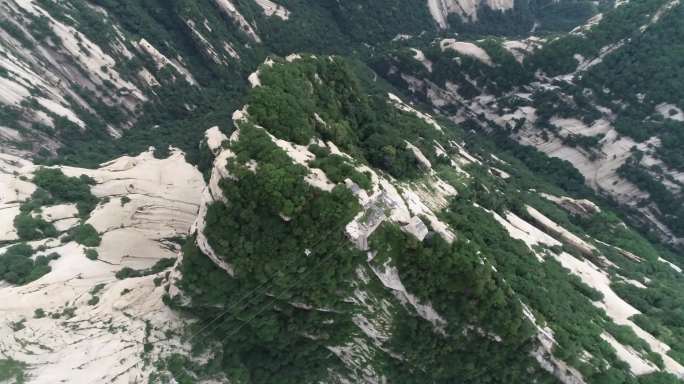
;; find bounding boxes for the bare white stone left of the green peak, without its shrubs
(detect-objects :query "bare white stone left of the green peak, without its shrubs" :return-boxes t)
[0,151,204,384]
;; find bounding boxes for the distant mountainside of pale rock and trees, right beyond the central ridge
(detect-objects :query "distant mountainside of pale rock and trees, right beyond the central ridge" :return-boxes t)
[377,1,684,243]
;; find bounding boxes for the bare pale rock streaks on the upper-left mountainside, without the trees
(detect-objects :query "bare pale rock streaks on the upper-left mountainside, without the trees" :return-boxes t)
[0,0,147,133]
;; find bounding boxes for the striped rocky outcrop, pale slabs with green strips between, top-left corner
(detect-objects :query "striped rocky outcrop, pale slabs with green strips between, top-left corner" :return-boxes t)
[0,0,148,151]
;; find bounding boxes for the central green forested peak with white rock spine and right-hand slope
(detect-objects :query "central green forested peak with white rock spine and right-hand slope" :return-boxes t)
[164,57,682,383]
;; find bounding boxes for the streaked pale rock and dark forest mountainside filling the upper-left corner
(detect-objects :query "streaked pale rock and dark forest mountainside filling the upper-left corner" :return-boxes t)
[0,0,260,162]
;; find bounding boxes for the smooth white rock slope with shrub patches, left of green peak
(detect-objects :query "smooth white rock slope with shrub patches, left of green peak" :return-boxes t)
[0,148,204,383]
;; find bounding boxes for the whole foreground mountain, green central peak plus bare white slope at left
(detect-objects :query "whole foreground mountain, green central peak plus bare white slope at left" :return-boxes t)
[0,55,684,384]
